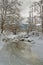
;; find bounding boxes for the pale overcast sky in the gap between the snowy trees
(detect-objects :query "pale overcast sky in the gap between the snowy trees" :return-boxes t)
[21,0,39,17]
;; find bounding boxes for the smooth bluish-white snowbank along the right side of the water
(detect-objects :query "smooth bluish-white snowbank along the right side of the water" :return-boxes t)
[29,36,43,58]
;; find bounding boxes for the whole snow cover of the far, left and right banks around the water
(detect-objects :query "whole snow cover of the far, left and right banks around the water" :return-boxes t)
[0,32,43,58]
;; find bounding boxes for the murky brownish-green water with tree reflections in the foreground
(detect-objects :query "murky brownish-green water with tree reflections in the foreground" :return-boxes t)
[1,42,43,65]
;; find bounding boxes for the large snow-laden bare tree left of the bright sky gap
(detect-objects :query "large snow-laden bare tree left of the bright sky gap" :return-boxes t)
[0,0,21,33]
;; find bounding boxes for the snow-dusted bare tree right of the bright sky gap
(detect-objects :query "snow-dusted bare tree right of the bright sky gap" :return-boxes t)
[30,1,43,32]
